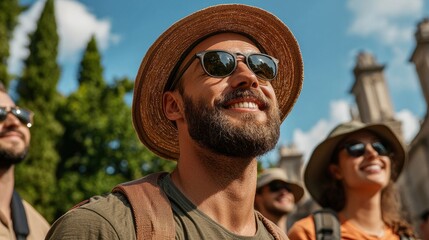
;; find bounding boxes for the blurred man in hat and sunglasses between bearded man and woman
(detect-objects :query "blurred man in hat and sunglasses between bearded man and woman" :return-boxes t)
[255,168,304,231]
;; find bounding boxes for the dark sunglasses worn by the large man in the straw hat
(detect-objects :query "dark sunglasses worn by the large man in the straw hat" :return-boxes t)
[169,50,279,91]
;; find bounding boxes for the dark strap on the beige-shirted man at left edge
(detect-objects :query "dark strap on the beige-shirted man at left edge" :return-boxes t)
[10,190,30,240]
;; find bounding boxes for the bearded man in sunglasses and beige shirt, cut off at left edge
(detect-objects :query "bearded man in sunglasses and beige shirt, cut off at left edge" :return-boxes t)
[0,83,50,240]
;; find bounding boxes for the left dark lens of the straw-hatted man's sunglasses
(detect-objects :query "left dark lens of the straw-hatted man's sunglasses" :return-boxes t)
[203,51,235,77]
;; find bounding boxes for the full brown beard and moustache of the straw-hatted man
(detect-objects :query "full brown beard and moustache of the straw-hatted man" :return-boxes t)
[183,89,281,158]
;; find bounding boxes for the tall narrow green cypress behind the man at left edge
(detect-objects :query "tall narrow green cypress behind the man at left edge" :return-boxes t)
[16,0,63,221]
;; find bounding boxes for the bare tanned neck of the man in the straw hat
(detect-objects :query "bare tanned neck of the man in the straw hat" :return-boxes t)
[172,149,257,236]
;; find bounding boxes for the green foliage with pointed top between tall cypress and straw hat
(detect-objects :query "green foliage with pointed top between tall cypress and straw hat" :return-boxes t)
[57,37,174,219]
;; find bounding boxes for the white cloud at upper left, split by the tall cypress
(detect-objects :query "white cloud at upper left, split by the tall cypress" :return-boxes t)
[9,0,120,74]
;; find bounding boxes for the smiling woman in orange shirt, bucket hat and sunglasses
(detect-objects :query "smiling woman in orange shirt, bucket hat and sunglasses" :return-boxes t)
[289,121,414,239]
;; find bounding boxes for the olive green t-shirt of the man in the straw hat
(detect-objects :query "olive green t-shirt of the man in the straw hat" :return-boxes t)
[46,175,274,240]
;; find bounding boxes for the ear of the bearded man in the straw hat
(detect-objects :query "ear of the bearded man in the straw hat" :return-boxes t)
[162,91,184,121]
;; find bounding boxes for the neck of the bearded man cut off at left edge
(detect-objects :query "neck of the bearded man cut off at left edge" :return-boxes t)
[0,166,15,220]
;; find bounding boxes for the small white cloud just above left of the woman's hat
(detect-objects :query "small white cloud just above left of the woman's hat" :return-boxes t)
[293,100,351,163]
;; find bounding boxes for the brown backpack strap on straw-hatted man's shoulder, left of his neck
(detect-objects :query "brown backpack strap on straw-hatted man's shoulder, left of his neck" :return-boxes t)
[112,172,176,240]
